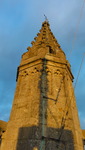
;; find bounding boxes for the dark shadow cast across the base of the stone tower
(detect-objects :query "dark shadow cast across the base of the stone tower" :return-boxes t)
[16,126,74,150]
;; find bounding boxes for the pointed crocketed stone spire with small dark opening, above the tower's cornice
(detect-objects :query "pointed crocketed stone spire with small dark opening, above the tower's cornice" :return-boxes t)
[27,18,66,61]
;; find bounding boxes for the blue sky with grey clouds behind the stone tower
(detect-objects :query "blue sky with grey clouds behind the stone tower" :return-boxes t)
[0,0,85,128]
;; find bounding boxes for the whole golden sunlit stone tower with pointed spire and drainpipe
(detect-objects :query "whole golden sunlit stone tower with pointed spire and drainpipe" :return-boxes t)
[1,21,83,150]
